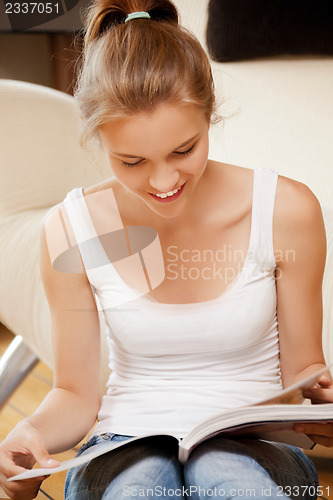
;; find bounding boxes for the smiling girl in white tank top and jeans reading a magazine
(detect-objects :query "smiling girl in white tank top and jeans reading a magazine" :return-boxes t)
[0,0,333,500]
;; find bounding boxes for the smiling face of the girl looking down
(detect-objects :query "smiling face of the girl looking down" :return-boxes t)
[99,104,209,218]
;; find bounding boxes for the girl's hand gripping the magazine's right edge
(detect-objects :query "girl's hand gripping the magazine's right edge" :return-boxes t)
[294,375,333,446]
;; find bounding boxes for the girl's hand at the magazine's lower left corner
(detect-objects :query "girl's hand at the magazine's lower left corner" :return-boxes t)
[0,422,59,500]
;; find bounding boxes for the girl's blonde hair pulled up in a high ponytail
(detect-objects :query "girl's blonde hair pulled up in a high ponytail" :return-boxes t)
[75,0,215,144]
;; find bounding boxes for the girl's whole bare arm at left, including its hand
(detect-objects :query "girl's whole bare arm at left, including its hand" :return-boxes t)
[0,204,100,500]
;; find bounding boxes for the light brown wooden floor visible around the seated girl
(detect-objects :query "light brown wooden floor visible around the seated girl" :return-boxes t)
[0,324,333,500]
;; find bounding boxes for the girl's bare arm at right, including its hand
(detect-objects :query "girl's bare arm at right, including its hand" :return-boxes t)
[274,178,333,446]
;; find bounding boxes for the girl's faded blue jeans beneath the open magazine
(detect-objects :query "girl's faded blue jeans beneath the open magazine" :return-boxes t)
[65,434,318,500]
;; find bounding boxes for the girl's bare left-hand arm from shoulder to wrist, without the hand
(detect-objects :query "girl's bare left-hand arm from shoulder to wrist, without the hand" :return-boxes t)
[28,207,100,453]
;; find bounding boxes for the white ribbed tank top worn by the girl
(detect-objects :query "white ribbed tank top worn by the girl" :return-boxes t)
[64,169,282,437]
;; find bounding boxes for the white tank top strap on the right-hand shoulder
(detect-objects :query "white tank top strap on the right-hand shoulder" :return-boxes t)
[250,168,278,269]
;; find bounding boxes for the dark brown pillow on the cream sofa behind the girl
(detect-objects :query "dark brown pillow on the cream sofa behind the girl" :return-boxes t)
[207,0,333,61]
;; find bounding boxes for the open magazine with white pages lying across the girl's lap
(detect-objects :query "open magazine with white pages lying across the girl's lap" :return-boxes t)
[8,367,333,481]
